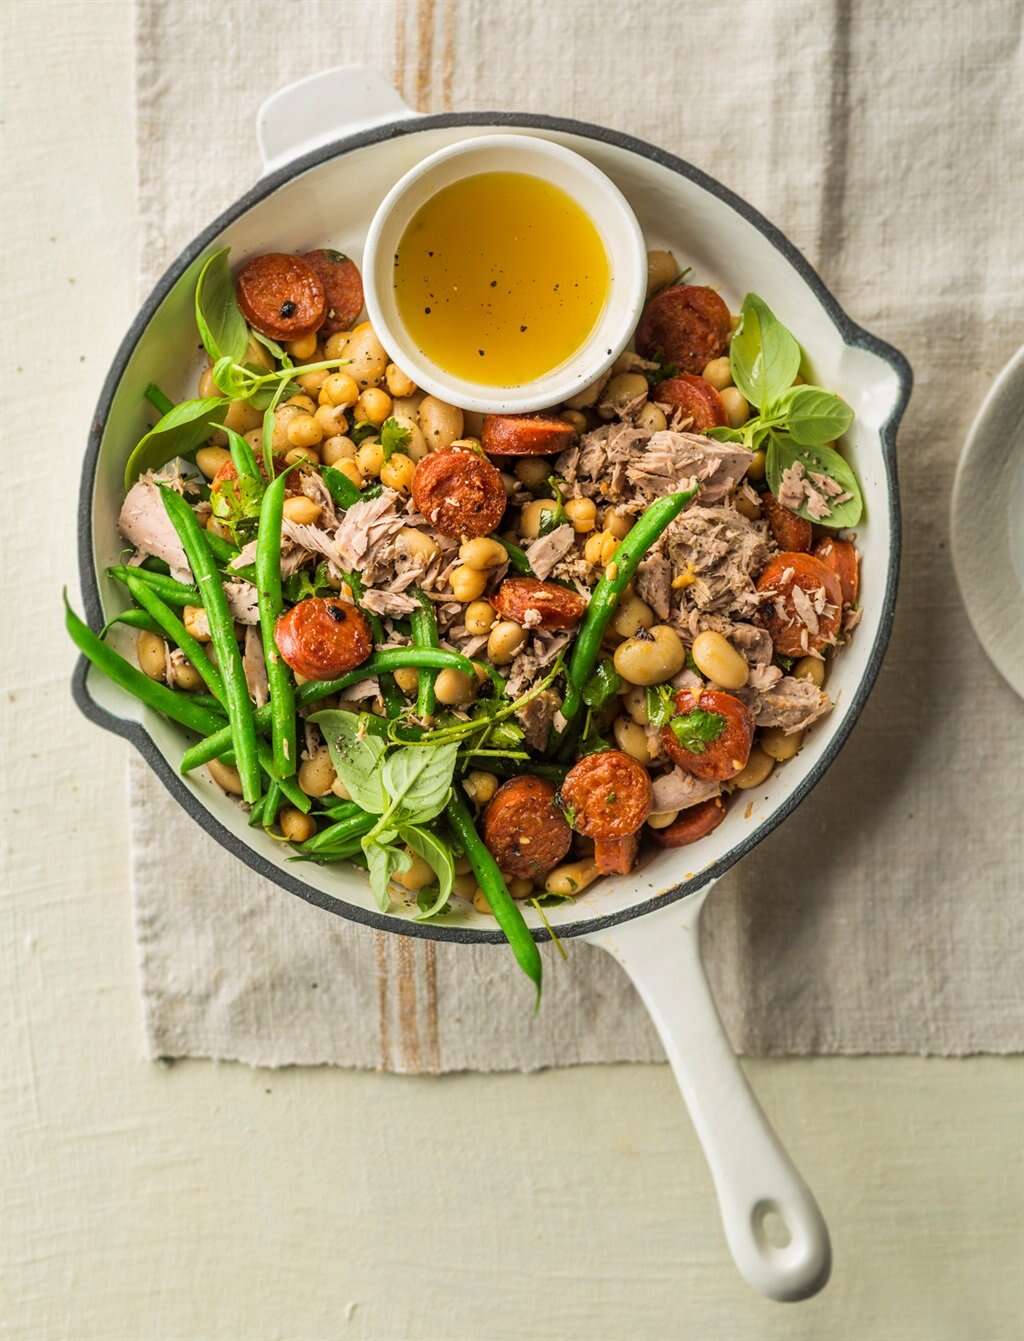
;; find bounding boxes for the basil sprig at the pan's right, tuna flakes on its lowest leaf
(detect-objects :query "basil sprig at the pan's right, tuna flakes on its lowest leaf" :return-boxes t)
[708,294,865,528]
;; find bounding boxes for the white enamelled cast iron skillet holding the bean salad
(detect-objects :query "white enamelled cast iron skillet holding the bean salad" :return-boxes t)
[75,68,911,1299]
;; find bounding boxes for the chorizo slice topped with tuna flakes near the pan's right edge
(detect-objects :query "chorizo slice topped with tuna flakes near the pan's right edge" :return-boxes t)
[757,550,843,657]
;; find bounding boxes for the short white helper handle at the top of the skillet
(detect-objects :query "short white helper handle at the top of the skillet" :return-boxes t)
[256,66,414,177]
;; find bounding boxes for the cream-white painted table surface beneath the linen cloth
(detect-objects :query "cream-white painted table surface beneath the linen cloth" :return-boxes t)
[0,0,1024,1341]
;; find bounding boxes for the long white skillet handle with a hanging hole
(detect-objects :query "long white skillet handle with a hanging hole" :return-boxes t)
[587,885,832,1299]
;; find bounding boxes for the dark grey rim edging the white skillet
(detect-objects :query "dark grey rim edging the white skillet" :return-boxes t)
[72,111,913,944]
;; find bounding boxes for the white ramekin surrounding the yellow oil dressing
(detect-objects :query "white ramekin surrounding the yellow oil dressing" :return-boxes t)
[363,135,647,413]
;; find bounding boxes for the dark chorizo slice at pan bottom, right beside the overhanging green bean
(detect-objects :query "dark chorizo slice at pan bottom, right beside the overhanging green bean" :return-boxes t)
[483,776,572,880]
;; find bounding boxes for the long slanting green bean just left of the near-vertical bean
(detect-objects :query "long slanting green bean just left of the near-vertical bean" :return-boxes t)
[159,485,261,803]
